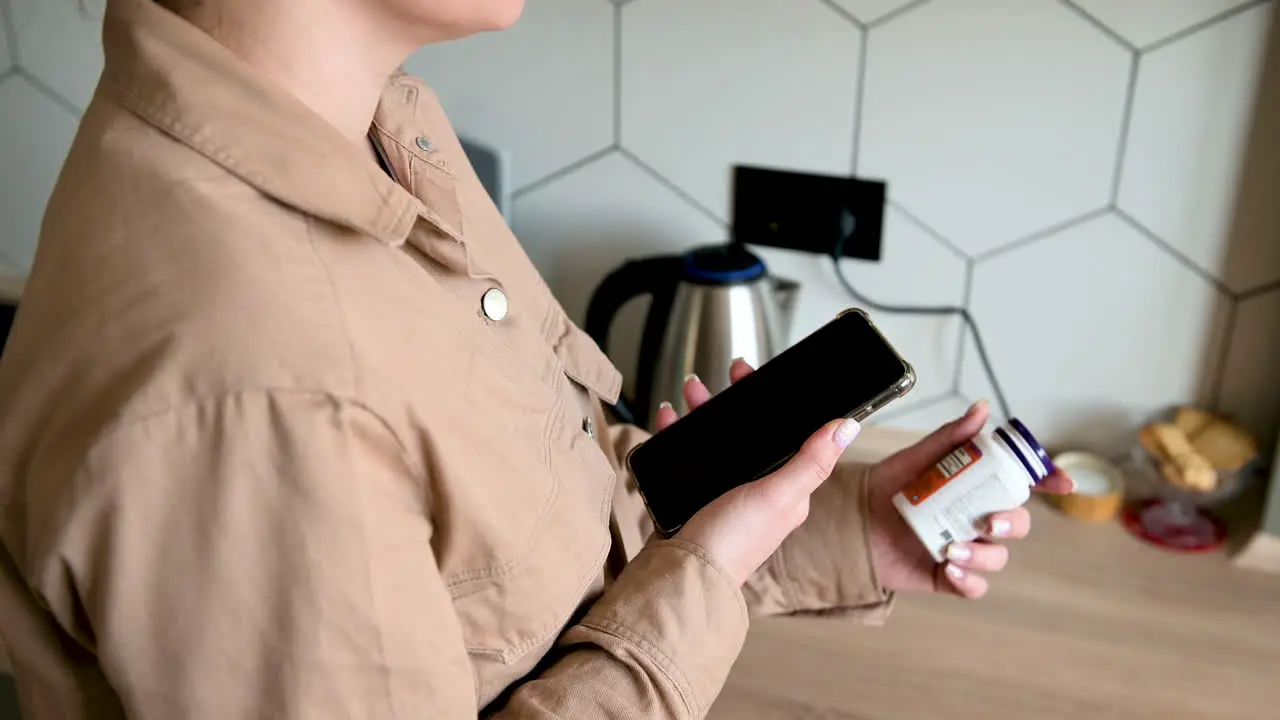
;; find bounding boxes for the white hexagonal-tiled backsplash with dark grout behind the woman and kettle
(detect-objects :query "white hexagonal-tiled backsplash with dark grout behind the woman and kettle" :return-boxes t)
[0,0,1280,451]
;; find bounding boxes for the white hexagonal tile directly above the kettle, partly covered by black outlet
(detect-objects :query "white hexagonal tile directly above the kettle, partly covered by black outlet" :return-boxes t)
[622,0,860,218]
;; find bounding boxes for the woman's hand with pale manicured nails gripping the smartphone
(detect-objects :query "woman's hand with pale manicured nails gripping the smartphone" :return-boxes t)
[658,363,860,584]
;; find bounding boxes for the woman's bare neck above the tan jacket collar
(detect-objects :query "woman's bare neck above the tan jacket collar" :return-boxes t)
[187,0,415,146]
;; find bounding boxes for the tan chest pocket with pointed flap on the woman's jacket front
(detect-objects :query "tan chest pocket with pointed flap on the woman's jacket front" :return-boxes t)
[449,311,621,674]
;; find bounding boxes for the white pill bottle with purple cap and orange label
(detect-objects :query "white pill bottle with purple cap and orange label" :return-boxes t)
[893,419,1053,562]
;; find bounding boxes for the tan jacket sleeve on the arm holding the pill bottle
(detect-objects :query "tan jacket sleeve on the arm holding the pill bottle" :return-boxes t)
[602,425,893,625]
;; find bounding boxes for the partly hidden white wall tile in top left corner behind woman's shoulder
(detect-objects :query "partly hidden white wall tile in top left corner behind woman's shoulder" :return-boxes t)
[9,0,105,108]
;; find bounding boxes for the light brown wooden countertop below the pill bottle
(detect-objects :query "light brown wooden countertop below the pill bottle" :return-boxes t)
[712,430,1280,720]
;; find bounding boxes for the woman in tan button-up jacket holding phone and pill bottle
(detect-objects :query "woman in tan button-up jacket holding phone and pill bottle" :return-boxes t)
[0,0,1070,719]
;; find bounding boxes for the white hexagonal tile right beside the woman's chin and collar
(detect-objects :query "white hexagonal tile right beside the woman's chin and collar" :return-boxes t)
[404,0,614,188]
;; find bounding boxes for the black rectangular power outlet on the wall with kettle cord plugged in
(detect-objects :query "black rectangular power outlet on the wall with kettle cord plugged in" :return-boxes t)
[732,165,886,260]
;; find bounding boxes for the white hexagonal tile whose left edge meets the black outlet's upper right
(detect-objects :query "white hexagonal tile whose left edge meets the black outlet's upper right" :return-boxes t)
[858,0,1129,254]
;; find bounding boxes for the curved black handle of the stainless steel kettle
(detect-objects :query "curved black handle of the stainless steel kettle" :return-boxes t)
[586,255,684,427]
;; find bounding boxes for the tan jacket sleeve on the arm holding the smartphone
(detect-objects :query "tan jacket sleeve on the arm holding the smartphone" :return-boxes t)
[35,393,748,720]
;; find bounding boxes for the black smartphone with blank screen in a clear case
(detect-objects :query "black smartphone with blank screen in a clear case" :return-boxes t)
[627,309,915,537]
